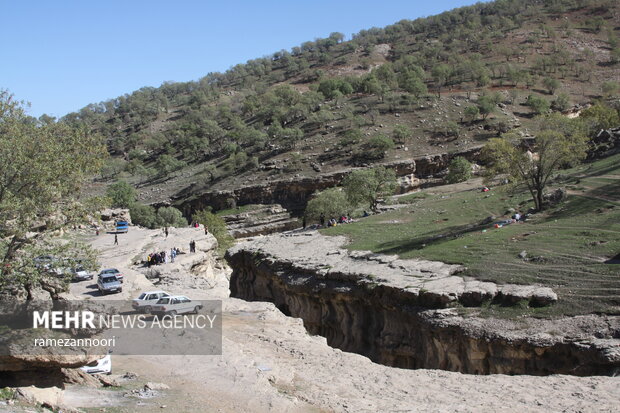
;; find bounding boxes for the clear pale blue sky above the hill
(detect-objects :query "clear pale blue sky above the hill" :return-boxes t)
[0,0,475,117]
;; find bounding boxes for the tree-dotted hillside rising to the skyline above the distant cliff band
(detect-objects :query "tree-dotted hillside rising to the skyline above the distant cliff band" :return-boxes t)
[68,0,620,211]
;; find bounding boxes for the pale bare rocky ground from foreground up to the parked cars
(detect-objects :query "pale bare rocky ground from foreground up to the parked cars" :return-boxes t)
[57,228,620,412]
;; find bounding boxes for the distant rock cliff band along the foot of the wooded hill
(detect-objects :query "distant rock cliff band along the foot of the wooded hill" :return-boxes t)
[174,148,480,216]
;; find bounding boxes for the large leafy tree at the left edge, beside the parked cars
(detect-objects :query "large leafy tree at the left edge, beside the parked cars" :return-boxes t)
[0,90,106,298]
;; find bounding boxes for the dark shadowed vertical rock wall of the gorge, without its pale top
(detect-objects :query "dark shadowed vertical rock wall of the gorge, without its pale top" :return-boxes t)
[227,243,620,375]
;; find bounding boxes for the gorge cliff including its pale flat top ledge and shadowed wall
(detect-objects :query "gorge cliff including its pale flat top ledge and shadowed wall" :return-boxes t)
[227,235,620,375]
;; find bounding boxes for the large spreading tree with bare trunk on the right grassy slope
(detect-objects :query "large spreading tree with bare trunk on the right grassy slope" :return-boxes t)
[482,118,587,211]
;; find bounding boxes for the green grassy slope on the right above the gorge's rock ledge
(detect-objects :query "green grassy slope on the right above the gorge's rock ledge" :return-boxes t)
[322,155,620,317]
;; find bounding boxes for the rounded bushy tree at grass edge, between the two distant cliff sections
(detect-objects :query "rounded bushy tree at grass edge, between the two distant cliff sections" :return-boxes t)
[342,166,396,211]
